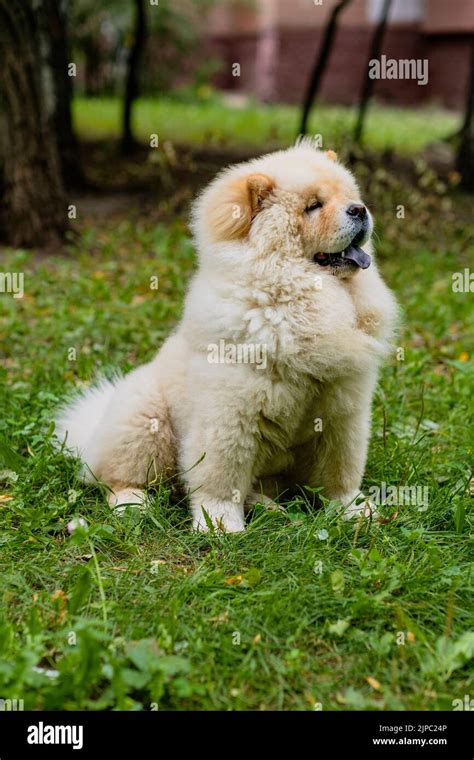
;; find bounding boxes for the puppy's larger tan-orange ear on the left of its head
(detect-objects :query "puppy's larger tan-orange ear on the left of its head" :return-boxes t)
[209,173,275,240]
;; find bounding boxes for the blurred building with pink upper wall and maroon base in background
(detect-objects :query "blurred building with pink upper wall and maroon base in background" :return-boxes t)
[205,0,474,108]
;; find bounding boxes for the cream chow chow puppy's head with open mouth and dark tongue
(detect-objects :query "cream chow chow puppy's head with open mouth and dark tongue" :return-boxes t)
[193,138,373,277]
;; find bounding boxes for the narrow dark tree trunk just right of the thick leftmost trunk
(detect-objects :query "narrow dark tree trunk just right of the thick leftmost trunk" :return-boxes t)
[42,0,86,189]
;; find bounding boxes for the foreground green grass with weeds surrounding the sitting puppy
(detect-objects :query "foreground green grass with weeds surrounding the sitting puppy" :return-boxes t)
[0,156,474,710]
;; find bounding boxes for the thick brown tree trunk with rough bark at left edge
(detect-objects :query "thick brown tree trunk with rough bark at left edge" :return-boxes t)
[0,0,68,247]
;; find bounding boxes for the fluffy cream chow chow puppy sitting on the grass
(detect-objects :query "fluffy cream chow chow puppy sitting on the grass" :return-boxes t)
[57,139,397,532]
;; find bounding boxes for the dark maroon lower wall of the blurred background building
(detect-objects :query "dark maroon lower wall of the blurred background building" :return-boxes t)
[207,25,472,108]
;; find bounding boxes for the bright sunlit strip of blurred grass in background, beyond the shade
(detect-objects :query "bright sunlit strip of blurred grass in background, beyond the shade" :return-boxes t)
[74,98,459,154]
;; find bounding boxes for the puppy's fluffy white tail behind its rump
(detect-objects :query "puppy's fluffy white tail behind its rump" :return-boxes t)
[55,377,120,457]
